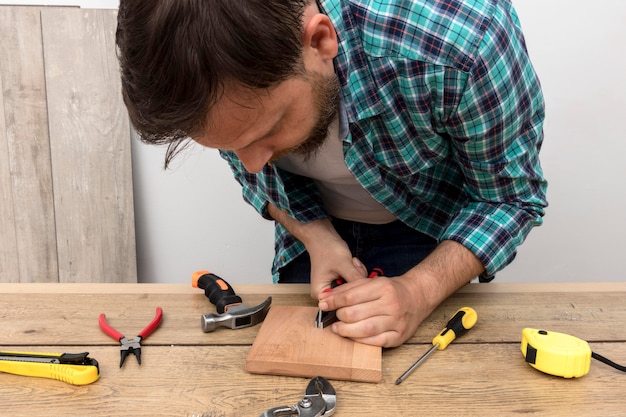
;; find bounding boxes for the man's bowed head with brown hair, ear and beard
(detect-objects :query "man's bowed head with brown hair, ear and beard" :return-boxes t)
[116,0,338,171]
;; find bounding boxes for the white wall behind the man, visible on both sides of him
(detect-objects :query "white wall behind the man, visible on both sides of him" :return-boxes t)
[3,0,626,283]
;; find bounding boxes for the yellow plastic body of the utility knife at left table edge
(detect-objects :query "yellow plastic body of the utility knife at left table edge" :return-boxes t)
[0,360,100,385]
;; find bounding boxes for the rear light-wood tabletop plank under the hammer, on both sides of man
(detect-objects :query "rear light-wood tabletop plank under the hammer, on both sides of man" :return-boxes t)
[0,284,626,345]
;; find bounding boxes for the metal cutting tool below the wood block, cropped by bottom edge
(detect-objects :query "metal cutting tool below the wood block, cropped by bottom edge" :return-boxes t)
[259,376,337,417]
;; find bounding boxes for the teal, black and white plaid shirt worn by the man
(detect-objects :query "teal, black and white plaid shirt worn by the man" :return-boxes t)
[222,0,547,279]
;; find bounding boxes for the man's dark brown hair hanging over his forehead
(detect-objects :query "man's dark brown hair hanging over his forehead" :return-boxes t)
[116,0,310,168]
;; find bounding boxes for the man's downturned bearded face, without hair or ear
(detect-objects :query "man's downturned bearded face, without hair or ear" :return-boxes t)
[193,71,339,173]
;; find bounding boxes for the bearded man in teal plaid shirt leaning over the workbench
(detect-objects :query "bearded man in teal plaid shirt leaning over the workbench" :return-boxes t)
[117,0,547,347]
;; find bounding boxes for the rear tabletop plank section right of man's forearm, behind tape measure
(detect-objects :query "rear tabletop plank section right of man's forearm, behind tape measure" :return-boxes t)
[410,284,626,343]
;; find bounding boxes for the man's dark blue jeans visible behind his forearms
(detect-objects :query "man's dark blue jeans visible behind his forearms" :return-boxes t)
[278,219,437,283]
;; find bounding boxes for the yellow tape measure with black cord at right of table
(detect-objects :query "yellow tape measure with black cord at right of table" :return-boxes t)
[521,328,626,378]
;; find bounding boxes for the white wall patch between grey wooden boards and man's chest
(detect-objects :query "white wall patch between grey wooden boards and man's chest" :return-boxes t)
[133,140,274,283]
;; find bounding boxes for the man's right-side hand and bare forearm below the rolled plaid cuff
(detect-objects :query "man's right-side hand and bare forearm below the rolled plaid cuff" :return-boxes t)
[319,241,483,347]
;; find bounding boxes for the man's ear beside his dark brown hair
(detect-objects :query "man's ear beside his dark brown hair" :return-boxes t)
[302,13,339,61]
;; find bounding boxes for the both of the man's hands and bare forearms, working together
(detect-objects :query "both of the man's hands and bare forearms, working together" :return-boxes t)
[268,204,484,347]
